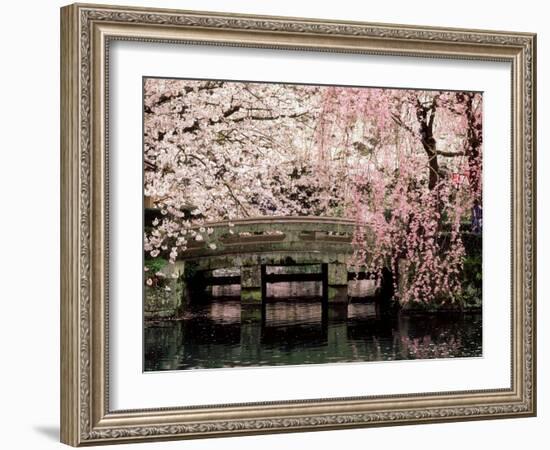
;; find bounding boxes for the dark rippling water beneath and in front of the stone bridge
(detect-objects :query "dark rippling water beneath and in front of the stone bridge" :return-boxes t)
[144,299,482,371]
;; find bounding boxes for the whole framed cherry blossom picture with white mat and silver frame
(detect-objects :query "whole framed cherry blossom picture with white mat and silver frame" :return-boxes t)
[61,4,536,446]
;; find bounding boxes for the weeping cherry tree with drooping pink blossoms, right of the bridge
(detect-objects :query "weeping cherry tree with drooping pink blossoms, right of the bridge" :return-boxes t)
[317,87,482,303]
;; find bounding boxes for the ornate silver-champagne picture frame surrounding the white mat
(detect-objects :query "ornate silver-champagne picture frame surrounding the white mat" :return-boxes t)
[61,4,536,446]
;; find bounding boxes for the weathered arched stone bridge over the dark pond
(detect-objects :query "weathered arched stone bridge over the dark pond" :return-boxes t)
[178,216,380,304]
